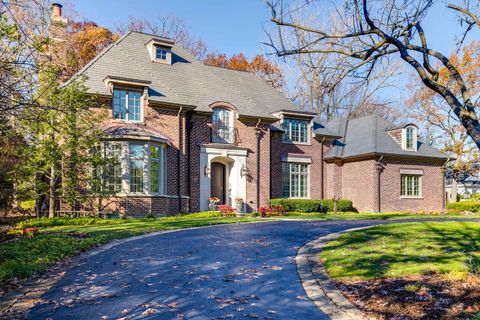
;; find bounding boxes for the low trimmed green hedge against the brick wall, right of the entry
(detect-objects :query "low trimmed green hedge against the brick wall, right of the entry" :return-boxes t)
[270,199,355,212]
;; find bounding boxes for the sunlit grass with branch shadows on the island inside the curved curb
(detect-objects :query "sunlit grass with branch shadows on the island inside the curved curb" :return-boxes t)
[320,221,480,280]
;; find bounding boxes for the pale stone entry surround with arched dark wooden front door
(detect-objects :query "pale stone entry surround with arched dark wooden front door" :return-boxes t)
[200,144,248,211]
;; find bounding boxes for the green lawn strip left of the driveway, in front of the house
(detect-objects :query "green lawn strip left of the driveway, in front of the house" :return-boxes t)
[0,214,258,284]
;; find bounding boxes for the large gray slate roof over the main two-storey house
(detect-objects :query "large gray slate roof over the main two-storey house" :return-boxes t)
[69,31,299,118]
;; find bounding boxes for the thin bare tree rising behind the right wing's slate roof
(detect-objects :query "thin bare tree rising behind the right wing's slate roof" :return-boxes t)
[277,10,399,120]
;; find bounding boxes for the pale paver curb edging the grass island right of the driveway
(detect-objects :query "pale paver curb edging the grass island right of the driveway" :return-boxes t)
[295,225,378,320]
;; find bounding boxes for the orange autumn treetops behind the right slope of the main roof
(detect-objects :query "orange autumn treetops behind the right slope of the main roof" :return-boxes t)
[203,53,284,89]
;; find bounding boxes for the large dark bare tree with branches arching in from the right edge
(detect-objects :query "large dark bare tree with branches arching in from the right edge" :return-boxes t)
[268,0,480,147]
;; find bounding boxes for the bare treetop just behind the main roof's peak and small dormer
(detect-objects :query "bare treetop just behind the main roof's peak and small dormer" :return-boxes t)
[116,15,207,60]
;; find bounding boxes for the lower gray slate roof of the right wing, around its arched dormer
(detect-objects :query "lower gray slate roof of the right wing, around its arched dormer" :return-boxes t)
[325,114,448,159]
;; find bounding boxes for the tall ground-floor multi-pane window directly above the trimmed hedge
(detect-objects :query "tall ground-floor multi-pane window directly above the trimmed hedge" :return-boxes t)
[282,162,309,198]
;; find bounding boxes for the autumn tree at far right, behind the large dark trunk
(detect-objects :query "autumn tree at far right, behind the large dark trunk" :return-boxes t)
[407,41,480,201]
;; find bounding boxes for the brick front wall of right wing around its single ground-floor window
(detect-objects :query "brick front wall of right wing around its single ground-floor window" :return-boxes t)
[380,160,444,212]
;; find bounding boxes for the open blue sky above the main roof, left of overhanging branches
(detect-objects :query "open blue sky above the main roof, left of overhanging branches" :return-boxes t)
[68,0,269,56]
